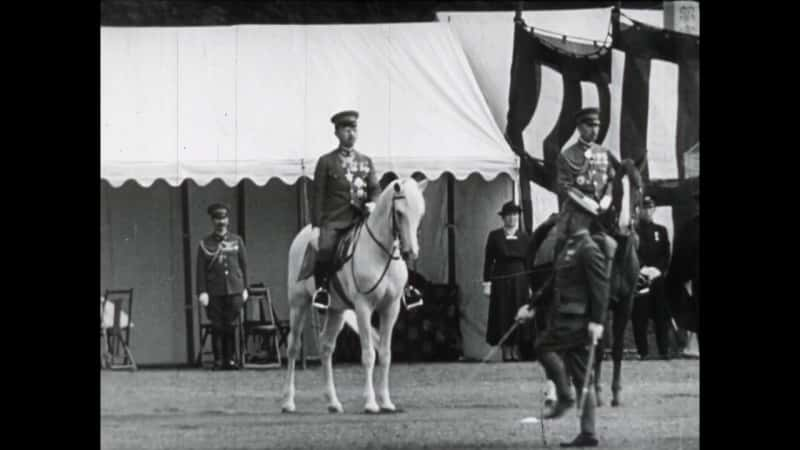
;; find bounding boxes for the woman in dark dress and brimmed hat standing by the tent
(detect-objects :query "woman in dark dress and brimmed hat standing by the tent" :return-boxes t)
[483,202,530,361]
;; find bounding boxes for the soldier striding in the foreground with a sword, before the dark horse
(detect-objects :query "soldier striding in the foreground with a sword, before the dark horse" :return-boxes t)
[517,191,613,447]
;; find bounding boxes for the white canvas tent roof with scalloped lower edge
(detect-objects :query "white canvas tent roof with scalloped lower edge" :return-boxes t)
[100,23,518,186]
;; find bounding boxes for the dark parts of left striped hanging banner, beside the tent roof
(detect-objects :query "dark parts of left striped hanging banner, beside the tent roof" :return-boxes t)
[506,20,611,231]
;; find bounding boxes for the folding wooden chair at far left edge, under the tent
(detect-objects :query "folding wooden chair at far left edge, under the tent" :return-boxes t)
[100,289,136,370]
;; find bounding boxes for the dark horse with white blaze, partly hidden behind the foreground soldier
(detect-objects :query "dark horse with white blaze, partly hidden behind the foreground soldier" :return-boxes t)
[530,162,641,406]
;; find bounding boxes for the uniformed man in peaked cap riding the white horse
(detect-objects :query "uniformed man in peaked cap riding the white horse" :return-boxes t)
[311,111,380,309]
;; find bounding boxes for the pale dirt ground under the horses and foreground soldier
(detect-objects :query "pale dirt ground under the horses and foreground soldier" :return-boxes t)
[100,360,700,450]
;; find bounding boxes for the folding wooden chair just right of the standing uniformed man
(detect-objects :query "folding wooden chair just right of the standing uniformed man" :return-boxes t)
[242,283,281,369]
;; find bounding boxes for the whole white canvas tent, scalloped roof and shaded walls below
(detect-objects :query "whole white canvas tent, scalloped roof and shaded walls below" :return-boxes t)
[100,23,518,364]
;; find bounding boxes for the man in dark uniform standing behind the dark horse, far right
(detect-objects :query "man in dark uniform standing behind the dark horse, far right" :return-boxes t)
[631,196,670,359]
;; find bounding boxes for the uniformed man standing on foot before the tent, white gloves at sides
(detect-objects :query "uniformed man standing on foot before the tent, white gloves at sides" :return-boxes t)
[197,203,247,370]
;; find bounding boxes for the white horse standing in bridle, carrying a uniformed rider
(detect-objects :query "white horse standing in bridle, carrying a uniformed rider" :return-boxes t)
[281,179,428,413]
